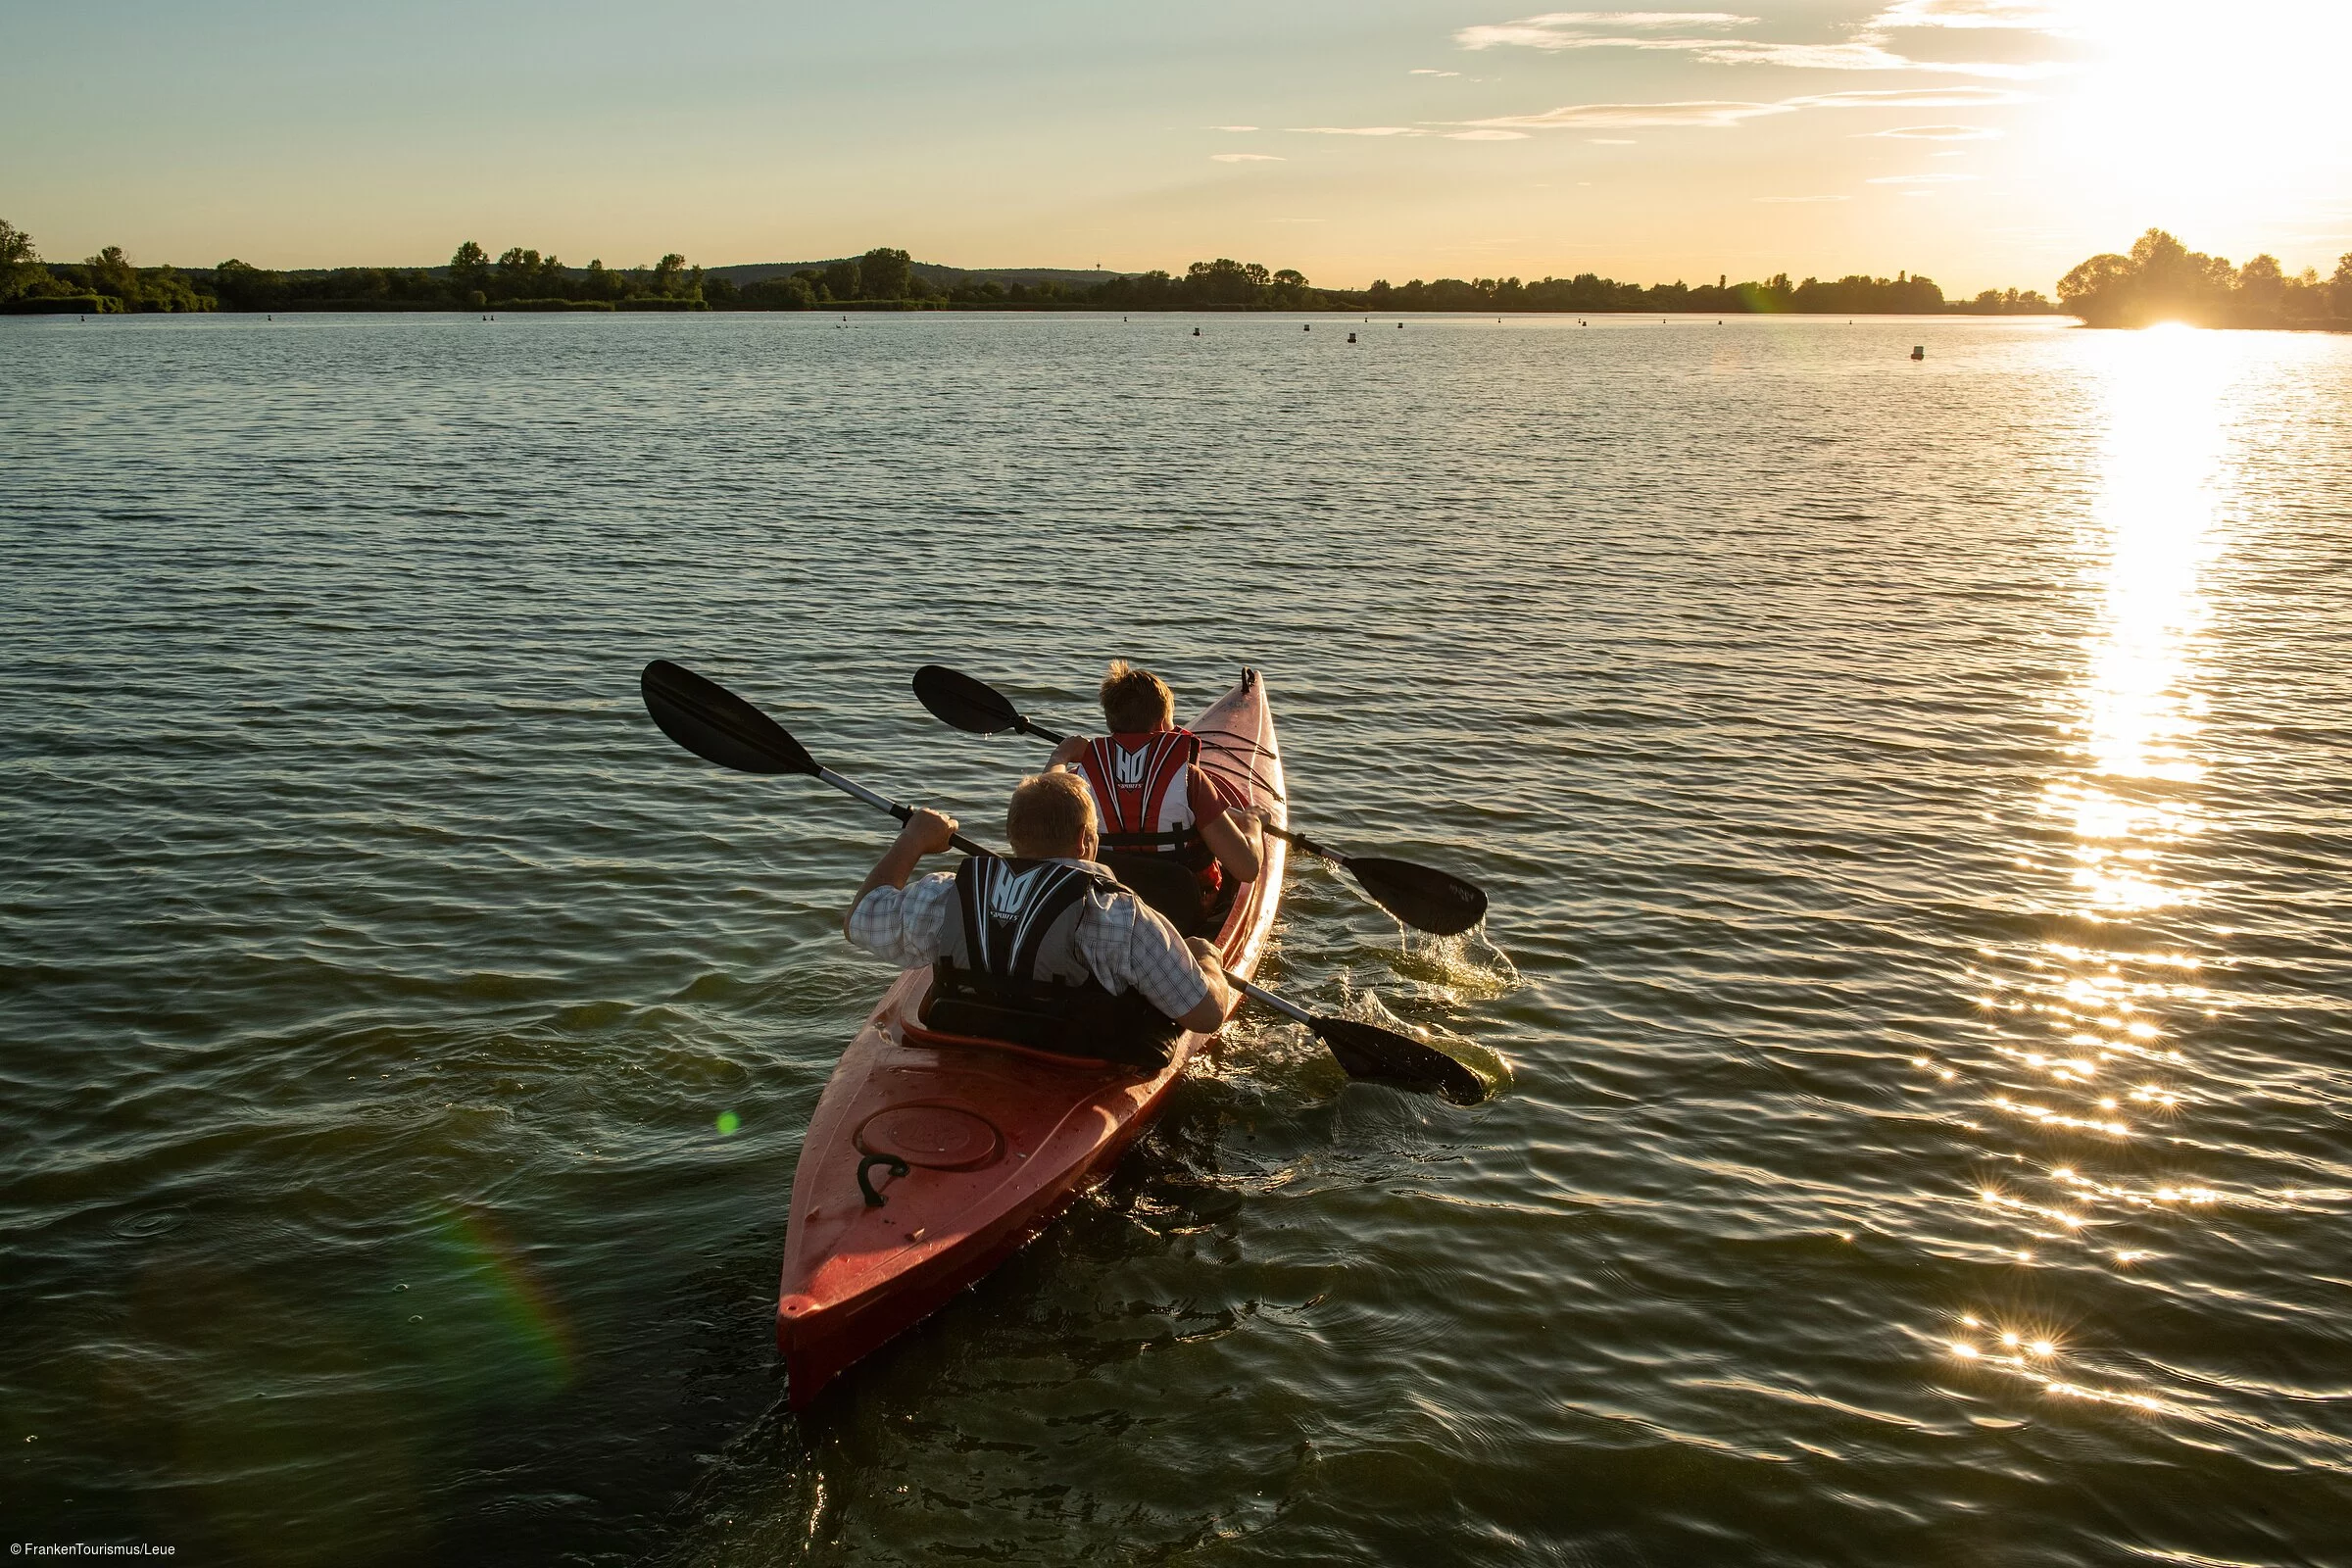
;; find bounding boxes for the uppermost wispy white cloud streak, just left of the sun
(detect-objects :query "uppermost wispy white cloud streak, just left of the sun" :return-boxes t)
[1453,0,2065,80]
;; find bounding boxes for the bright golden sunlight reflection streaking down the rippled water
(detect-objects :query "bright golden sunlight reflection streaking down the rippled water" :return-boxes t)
[1950,331,2234,1413]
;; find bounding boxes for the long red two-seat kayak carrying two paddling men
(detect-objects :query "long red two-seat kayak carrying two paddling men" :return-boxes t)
[776,670,1289,1410]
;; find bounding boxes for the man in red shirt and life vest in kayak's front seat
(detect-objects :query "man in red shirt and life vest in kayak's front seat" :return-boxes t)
[1054,659,1265,931]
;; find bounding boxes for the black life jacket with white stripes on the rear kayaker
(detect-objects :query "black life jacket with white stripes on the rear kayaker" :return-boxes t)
[922,856,1183,1069]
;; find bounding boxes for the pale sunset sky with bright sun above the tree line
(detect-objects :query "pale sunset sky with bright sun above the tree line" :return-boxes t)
[0,0,2352,294]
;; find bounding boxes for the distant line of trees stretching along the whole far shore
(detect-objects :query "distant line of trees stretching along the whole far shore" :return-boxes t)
[0,220,2352,326]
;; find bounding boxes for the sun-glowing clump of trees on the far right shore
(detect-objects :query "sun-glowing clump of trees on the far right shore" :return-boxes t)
[2058,228,2352,326]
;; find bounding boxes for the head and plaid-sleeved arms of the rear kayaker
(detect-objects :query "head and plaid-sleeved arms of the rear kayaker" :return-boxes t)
[842,771,1233,1034]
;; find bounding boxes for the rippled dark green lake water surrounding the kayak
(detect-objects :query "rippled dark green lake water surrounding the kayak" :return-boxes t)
[0,315,2352,1568]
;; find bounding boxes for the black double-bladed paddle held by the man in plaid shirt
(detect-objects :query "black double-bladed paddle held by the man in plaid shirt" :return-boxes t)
[640,659,1487,1104]
